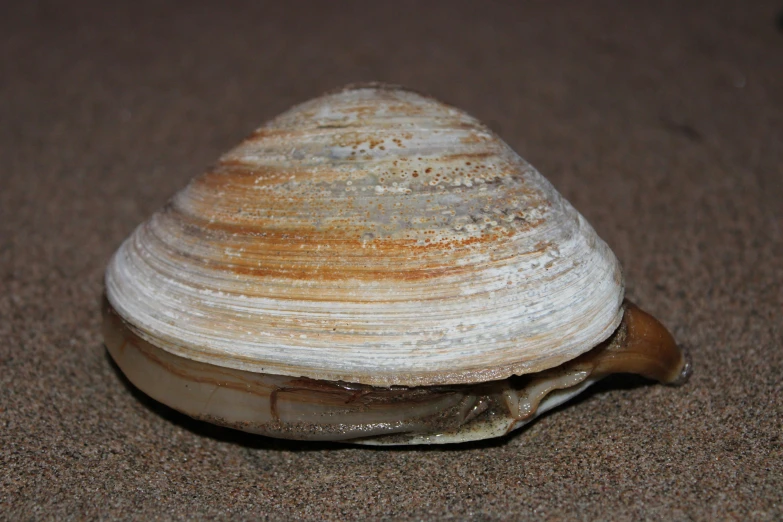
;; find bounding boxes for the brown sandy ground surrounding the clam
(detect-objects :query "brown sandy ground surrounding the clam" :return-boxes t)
[0,0,783,520]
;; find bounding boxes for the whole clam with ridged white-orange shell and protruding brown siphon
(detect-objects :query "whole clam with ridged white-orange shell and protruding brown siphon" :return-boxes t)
[104,84,689,444]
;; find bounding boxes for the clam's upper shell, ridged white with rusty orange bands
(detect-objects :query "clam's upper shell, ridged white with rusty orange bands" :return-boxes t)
[106,85,623,386]
